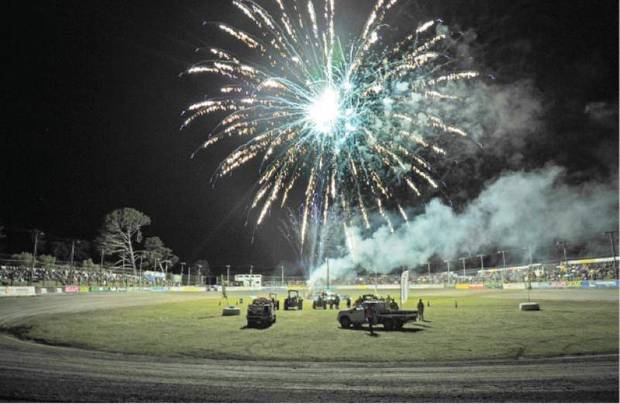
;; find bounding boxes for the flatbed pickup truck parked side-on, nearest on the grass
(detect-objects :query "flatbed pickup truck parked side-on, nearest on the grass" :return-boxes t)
[338,300,418,331]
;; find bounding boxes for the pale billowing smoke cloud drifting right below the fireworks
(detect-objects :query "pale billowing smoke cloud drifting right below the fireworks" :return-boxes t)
[311,166,618,281]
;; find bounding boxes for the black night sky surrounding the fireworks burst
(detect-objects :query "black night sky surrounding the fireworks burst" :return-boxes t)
[0,0,618,267]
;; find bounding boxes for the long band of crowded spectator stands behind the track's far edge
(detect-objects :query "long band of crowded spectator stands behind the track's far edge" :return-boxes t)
[0,257,619,288]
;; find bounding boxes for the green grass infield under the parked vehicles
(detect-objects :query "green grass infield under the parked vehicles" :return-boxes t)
[12,290,618,361]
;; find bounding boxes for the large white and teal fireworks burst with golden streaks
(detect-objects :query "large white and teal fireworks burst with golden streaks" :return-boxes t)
[184,0,478,243]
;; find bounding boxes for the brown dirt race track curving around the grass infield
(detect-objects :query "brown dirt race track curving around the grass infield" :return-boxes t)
[0,294,618,402]
